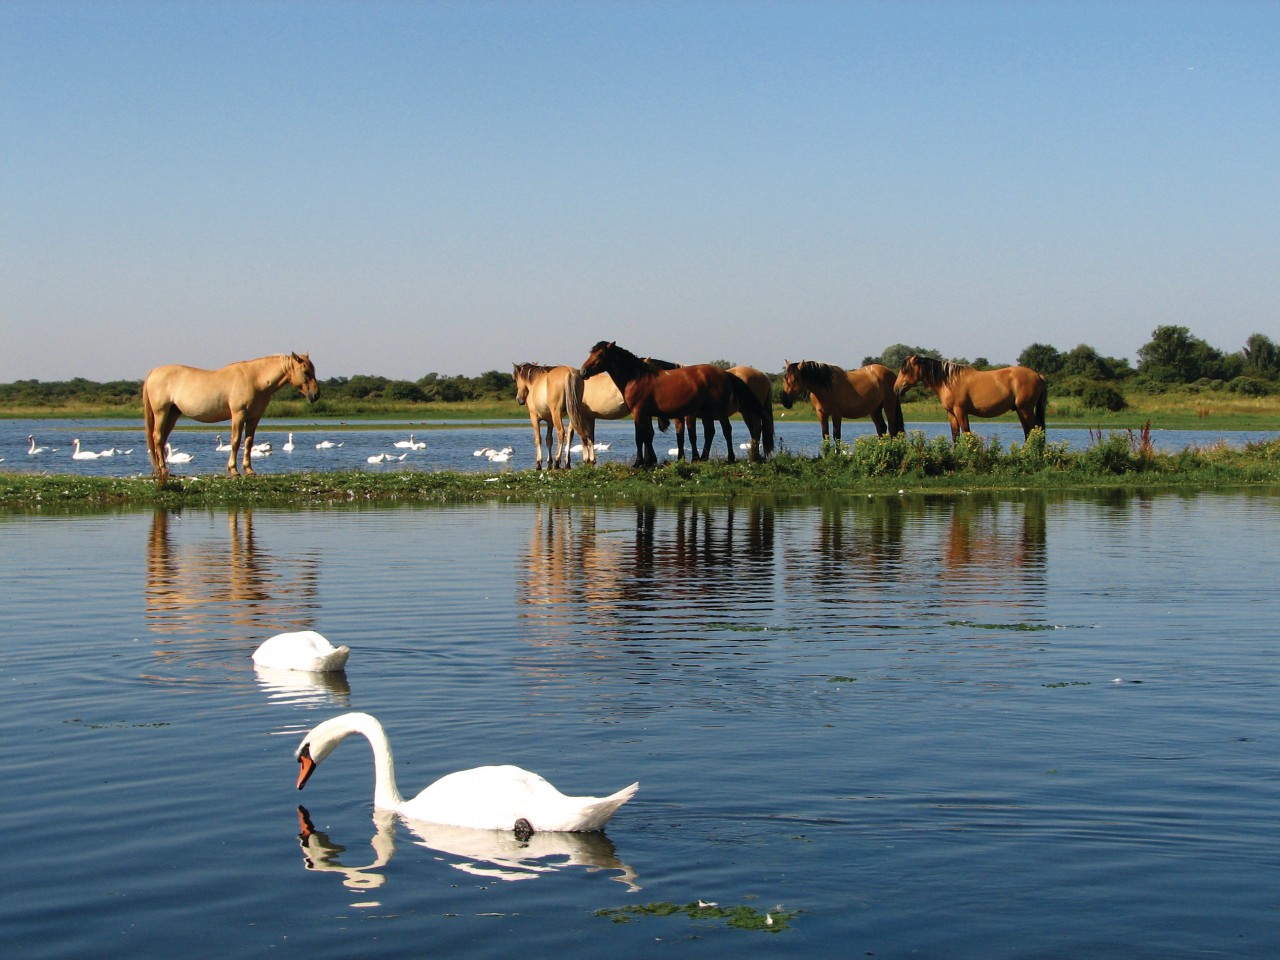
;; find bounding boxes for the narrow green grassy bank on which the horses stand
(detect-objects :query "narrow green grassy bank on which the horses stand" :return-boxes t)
[0,430,1280,513]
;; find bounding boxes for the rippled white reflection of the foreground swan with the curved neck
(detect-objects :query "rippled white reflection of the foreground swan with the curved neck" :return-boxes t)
[298,806,640,892]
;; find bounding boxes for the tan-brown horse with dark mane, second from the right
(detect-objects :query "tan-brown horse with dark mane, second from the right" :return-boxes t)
[781,360,906,440]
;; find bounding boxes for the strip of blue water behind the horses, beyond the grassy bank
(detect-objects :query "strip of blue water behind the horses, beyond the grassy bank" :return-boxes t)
[0,410,1280,476]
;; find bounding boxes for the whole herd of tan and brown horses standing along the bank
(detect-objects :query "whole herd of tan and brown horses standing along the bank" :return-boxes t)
[142,340,1048,483]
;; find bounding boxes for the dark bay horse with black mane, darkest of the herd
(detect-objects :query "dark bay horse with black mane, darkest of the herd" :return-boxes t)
[582,340,773,466]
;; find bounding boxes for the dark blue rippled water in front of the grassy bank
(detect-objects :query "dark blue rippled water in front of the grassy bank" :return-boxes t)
[0,491,1280,960]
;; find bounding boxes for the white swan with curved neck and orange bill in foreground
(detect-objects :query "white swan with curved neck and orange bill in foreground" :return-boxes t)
[293,713,640,832]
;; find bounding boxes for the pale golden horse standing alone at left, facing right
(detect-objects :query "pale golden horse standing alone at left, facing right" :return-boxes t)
[142,353,320,483]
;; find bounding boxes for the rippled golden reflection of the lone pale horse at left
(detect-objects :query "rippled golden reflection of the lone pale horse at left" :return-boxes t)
[143,509,320,643]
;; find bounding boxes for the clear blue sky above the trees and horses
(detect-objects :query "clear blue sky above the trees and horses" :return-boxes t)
[0,0,1280,381]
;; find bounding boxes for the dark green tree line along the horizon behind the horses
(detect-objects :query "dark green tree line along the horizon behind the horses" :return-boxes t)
[0,325,1280,410]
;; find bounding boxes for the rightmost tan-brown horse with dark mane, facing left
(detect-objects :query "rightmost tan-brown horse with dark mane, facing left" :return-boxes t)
[893,353,1048,443]
